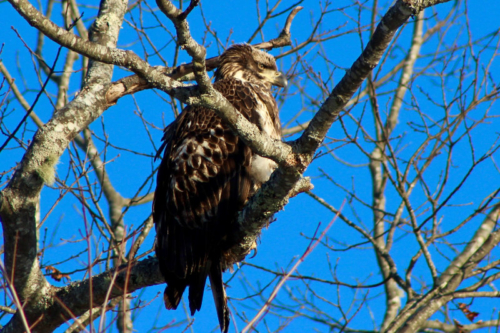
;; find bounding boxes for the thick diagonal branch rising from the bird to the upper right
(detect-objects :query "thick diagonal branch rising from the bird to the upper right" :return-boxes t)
[225,0,448,270]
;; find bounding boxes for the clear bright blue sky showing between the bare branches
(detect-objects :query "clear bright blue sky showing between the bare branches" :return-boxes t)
[0,1,500,332]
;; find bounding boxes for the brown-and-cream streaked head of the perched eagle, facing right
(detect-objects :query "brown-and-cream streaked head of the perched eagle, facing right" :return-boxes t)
[215,44,288,89]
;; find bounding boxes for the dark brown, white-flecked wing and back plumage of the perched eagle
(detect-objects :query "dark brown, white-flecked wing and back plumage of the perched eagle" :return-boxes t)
[153,79,257,282]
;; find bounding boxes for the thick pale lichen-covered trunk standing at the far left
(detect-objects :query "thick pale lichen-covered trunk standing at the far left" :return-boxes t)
[0,0,127,332]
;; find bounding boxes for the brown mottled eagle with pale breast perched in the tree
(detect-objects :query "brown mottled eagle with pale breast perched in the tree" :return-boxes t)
[153,44,287,332]
